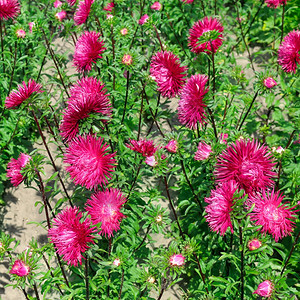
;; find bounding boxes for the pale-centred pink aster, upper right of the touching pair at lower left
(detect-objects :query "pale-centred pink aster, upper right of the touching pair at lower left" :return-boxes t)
[86,189,127,237]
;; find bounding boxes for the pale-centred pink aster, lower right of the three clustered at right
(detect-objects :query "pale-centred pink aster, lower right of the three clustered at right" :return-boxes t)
[247,190,298,242]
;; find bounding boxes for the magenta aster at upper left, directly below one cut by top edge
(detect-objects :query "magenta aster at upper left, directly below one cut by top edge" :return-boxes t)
[73,31,106,72]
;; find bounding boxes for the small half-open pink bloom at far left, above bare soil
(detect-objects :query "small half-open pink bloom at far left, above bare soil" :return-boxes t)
[6,153,31,186]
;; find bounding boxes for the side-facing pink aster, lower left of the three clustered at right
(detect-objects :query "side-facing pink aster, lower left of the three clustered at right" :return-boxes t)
[205,180,238,235]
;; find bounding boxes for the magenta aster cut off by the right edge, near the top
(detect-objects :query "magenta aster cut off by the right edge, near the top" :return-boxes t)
[278,30,300,73]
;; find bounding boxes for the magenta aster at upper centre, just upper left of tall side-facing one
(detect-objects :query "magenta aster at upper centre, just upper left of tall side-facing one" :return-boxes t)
[150,51,187,98]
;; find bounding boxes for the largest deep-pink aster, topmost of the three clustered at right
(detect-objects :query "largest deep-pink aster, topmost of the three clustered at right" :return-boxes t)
[215,139,277,193]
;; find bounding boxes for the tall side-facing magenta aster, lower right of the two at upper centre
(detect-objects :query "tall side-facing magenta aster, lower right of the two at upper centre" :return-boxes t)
[178,74,209,129]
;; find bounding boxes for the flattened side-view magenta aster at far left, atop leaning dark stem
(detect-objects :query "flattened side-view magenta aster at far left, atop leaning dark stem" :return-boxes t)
[5,79,43,108]
